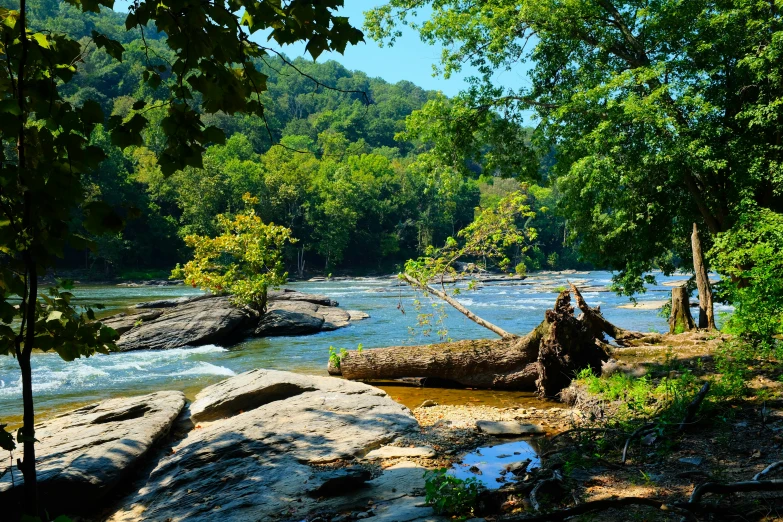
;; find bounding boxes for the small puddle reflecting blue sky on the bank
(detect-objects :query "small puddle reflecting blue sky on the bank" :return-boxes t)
[449,439,541,489]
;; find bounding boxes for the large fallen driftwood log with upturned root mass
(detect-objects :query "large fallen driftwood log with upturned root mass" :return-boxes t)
[329,287,645,397]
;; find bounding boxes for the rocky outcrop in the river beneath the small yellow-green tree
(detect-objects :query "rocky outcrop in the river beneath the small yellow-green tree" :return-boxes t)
[102,289,369,351]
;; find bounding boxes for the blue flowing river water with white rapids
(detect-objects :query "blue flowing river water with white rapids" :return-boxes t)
[0,272,720,423]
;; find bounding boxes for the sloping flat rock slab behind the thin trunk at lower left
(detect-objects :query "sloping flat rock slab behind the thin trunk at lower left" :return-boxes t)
[0,391,185,515]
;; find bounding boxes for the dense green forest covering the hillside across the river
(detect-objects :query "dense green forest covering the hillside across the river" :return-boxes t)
[12,1,580,277]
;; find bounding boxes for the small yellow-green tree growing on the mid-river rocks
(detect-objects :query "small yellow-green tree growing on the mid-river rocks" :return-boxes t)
[172,193,296,310]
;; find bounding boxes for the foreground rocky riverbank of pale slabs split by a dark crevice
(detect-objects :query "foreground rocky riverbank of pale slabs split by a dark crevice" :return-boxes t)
[0,370,564,522]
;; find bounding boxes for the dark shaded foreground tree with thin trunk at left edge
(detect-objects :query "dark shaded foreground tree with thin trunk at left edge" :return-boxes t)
[0,0,362,516]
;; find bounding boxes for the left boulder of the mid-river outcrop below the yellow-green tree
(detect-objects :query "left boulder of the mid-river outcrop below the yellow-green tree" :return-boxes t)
[117,297,253,352]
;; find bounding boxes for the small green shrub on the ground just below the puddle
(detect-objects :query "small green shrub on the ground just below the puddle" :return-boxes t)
[424,468,482,515]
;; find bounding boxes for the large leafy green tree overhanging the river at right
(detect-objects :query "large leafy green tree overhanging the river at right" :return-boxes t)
[366,0,783,292]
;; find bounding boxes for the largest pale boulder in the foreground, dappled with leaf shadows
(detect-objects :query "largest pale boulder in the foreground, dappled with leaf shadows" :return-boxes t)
[110,370,426,521]
